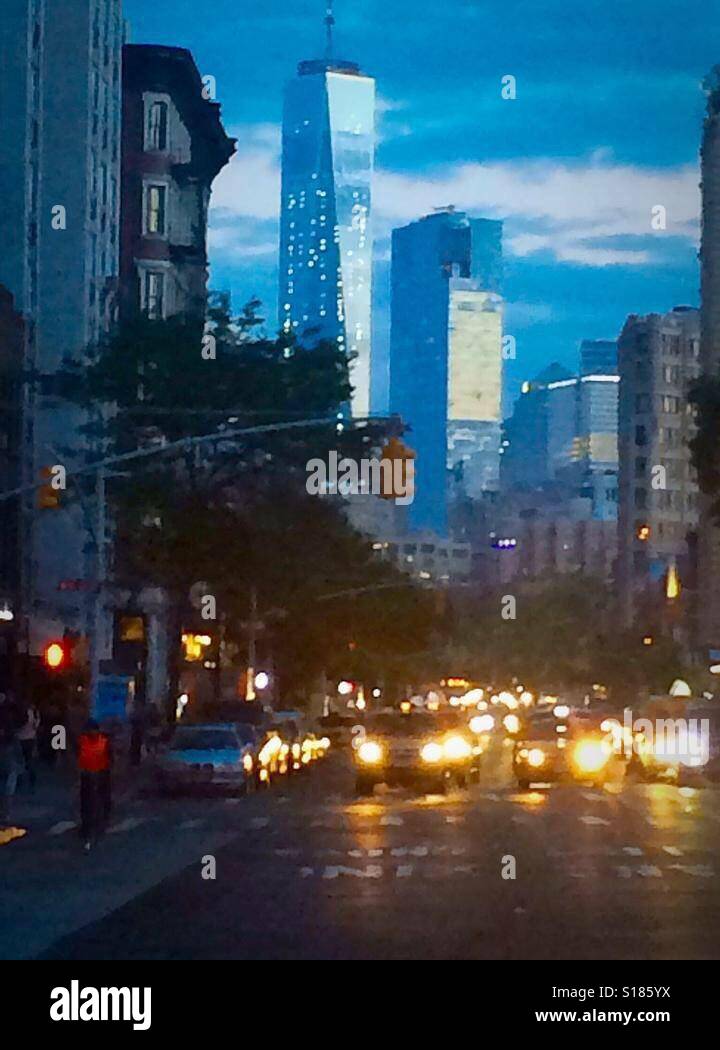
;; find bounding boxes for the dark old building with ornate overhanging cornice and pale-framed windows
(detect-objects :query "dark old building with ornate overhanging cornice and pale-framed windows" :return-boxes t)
[120,44,235,319]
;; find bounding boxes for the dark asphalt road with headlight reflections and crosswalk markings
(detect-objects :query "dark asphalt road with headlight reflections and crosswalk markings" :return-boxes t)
[0,749,720,960]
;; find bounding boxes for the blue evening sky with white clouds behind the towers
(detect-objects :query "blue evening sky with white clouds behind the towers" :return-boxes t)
[124,0,720,409]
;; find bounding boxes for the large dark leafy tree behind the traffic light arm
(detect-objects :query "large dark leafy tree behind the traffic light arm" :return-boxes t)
[60,296,428,697]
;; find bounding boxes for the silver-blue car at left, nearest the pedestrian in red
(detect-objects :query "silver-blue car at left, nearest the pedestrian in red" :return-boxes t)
[157,722,259,793]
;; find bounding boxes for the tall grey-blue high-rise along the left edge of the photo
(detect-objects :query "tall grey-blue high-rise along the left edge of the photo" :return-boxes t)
[0,0,123,652]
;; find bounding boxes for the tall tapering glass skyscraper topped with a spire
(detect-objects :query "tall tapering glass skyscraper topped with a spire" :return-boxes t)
[279,3,375,416]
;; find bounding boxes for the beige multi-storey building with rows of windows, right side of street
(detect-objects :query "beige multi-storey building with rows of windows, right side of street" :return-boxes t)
[617,307,700,631]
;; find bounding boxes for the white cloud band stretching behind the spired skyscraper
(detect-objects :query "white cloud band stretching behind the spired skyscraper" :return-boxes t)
[211,120,700,267]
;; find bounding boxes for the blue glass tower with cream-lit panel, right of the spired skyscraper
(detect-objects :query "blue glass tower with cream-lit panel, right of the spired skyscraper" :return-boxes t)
[389,208,503,536]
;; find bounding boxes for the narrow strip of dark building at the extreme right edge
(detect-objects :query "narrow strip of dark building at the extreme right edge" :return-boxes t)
[698,65,720,650]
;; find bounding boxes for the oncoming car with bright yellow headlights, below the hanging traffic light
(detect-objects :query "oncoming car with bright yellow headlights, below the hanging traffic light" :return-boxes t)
[353,710,479,795]
